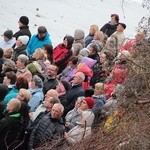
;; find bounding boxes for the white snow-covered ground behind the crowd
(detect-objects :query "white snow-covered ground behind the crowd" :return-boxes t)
[0,0,148,45]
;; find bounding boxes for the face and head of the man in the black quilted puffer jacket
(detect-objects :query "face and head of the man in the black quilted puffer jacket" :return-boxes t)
[51,105,62,119]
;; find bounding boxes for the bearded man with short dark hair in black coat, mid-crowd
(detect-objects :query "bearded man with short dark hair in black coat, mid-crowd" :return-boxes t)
[43,64,58,94]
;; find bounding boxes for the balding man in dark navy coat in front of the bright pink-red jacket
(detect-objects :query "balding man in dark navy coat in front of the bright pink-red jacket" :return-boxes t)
[64,72,85,114]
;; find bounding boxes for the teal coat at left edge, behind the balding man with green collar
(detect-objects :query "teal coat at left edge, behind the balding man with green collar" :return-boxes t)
[4,87,19,108]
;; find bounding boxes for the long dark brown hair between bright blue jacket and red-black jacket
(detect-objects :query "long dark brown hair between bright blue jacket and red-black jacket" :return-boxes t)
[44,44,53,63]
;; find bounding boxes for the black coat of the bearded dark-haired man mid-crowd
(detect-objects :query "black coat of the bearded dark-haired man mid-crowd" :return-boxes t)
[43,76,58,95]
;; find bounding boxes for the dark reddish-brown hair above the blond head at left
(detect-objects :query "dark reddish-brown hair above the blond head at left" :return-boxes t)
[15,77,29,90]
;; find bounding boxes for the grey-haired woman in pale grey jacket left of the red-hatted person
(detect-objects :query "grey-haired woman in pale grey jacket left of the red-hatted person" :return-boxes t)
[65,96,85,130]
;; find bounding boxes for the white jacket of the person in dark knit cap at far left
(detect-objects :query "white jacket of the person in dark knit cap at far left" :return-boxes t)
[0,37,16,49]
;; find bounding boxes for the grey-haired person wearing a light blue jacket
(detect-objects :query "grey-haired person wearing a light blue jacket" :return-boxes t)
[28,75,44,112]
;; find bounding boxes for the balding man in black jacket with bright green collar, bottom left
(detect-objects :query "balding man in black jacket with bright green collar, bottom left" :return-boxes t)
[0,98,22,150]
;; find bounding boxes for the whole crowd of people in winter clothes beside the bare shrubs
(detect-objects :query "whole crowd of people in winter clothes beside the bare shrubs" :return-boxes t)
[0,14,145,150]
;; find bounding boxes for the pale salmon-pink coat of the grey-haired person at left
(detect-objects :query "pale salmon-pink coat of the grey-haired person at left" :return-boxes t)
[16,68,32,82]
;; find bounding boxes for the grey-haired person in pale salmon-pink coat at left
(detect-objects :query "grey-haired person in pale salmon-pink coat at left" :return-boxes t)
[16,54,32,82]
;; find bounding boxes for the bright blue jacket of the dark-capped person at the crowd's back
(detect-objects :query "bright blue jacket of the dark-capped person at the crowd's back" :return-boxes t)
[27,33,52,56]
